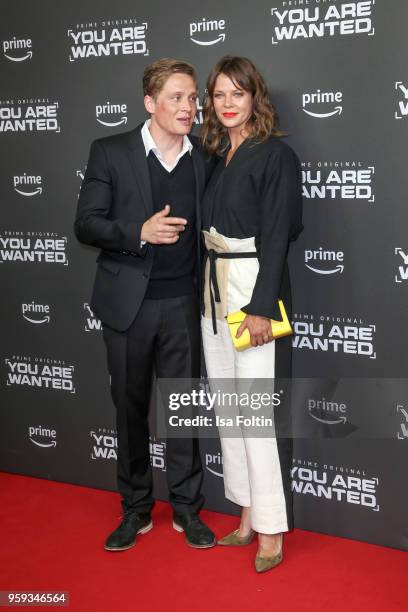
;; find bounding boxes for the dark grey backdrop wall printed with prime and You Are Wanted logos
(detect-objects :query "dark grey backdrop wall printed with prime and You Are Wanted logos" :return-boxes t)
[0,0,408,550]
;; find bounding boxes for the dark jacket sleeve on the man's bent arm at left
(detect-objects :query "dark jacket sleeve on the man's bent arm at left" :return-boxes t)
[74,140,146,257]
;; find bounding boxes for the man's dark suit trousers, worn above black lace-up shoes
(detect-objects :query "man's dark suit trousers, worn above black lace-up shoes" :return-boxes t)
[103,294,203,514]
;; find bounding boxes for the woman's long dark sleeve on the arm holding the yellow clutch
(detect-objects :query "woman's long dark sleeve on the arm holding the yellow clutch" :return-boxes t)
[242,143,303,320]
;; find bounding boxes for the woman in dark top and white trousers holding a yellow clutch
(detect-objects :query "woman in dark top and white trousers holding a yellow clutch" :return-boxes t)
[202,56,303,572]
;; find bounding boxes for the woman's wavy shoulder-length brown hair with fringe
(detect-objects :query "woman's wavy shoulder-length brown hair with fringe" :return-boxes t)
[201,55,284,154]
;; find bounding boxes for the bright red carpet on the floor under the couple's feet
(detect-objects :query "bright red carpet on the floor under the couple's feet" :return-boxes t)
[0,473,408,612]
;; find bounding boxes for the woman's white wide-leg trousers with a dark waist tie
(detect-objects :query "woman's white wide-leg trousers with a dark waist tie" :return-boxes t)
[202,230,288,534]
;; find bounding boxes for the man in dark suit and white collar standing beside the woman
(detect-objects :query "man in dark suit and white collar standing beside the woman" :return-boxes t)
[75,59,215,551]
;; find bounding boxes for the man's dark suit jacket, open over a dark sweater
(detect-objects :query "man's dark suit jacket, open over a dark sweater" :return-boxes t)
[74,124,211,331]
